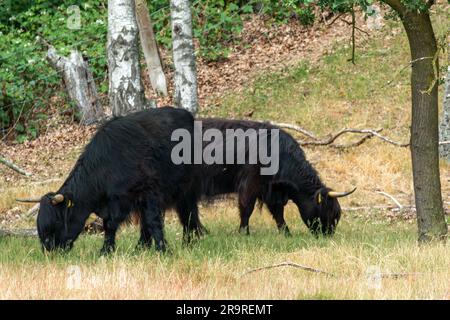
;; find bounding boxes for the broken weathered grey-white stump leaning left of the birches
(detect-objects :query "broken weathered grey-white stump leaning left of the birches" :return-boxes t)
[47,47,103,124]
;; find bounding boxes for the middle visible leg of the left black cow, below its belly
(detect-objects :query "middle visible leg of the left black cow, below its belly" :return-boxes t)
[141,197,166,251]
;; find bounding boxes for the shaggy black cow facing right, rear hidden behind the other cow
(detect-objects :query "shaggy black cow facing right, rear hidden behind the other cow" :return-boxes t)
[186,119,354,235]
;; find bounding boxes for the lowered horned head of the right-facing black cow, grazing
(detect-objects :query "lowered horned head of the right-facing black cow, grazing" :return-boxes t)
[297,187,356,235]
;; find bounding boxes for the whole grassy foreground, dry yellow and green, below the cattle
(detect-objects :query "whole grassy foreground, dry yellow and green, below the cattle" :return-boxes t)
[0,205,450,299]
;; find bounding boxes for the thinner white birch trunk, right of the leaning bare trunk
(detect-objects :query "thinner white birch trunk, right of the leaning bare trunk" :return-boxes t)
[170,0,198,115]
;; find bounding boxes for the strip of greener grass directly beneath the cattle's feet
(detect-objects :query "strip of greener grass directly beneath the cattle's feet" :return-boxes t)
[0,204,416,265]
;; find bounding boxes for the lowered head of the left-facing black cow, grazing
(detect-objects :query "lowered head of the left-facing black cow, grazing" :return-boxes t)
[37,192,87,251]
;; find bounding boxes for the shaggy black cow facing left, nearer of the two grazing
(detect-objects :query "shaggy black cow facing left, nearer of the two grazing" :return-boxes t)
[37,107,201,253]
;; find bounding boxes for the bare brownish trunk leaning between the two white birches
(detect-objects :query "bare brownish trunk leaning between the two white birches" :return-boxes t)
[135,0,167,96]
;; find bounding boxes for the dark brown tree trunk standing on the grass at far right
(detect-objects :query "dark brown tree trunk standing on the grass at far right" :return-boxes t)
[385,0,447,242]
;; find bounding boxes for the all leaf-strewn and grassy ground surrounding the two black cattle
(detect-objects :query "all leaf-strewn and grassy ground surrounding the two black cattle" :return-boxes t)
[0,8,450,299]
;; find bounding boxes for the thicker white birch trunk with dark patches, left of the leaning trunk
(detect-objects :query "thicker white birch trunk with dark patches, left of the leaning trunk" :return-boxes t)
[107,0,145,116]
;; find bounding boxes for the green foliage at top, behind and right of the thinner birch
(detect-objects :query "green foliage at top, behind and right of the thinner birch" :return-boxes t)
[149,0,314,61]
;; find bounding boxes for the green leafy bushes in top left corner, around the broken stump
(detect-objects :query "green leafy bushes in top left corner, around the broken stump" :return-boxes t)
[0,0,107,142]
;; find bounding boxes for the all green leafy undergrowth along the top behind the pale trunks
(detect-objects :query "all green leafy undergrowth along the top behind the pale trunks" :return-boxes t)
[0,0,314,141]
